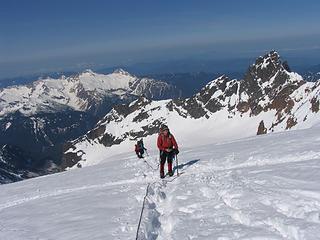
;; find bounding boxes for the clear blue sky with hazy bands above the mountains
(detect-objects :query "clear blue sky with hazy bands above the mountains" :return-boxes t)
[0,0,320,79]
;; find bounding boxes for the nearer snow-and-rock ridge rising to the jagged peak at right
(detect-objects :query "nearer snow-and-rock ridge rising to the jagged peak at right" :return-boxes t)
[63,51,320,167]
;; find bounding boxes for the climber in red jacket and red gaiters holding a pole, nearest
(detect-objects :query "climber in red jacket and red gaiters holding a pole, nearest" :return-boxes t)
[157,125,179,178]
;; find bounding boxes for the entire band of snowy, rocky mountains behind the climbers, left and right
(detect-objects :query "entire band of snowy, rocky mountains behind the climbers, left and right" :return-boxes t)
[0,51,320,183]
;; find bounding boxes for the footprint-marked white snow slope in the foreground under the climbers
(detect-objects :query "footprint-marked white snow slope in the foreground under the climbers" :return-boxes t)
[0,125,320,240]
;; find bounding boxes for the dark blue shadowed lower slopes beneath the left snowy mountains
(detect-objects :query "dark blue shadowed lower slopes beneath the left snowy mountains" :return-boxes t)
[0,111,93,177]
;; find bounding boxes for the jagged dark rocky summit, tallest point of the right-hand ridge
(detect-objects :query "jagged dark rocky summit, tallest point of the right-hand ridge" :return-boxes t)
[240,51,304,115]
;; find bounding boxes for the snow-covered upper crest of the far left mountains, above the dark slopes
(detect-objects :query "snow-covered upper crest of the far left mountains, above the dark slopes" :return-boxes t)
[0,69,175,116]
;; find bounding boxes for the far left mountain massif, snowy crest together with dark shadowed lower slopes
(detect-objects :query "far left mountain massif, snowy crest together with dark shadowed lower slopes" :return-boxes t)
[0,69,178,184]
